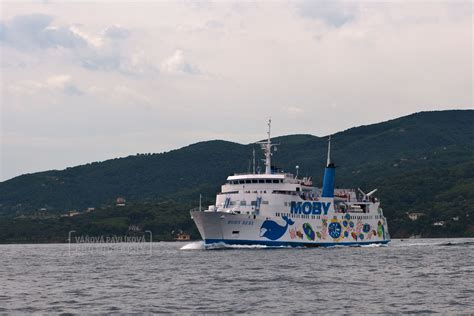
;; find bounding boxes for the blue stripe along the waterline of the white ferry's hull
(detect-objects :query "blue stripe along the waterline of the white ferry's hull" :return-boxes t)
[204,239,390,247]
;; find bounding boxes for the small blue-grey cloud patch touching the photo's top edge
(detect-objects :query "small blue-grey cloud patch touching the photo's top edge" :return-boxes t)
[297,0,357,27]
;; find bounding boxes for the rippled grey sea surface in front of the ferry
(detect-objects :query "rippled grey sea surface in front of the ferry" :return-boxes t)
[0,239,474,314]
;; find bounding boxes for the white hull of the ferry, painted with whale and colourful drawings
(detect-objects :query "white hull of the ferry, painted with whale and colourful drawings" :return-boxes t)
[191,211,390,247]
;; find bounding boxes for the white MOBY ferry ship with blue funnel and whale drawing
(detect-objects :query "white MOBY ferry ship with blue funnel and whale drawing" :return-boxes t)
[191,120,390,247]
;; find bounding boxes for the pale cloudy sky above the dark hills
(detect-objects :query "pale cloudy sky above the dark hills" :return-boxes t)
[0,0,474,181]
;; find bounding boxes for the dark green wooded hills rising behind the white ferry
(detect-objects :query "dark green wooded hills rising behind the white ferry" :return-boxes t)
[0,110,474,239]
